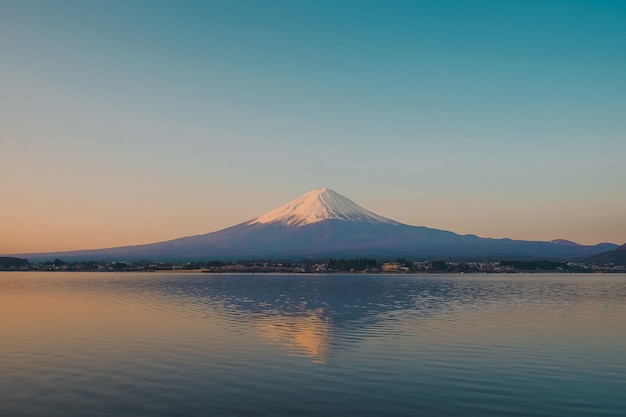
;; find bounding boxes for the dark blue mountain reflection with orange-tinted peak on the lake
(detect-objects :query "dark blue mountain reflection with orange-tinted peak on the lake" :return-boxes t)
[150,274,464,364]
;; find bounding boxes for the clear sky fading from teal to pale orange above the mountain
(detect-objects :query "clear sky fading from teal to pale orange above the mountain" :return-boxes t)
[0,0,626,254]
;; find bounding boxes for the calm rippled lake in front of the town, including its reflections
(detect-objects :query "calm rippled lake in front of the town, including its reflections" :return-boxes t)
[0,272,626,417]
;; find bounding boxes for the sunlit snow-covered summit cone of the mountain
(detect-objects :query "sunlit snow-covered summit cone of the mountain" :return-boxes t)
[248,188,398,226]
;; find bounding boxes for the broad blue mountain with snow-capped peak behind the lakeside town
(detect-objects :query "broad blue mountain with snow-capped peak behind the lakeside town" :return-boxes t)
[13,188,617,261]
